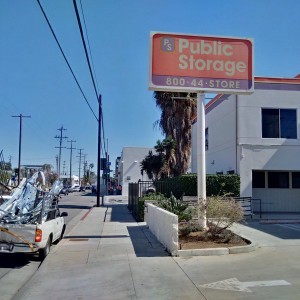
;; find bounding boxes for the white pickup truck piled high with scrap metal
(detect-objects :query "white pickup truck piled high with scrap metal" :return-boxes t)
[0,173,68,259]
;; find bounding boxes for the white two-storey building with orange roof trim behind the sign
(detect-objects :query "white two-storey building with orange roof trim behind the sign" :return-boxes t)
[192,76,300,212]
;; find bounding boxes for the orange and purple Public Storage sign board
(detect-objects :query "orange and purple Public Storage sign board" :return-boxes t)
[149,32,254,93]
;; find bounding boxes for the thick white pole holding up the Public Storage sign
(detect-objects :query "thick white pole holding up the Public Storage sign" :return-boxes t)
[197,92,207,228]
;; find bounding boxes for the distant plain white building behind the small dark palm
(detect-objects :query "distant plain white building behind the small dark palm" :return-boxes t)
[118,147,156,195]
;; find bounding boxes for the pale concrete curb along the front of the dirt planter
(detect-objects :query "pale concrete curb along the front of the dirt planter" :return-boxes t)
[175,243,257,257]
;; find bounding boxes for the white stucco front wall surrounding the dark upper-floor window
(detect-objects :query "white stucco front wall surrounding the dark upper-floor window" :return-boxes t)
[237,90,300,196]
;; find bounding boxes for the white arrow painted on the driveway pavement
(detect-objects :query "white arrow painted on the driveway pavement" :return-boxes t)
[200,278,291,293]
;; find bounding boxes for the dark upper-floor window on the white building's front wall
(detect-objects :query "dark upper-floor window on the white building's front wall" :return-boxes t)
[262,108,297,139]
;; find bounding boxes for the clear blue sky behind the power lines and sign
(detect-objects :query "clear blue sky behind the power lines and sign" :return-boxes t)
[0,0,300,174]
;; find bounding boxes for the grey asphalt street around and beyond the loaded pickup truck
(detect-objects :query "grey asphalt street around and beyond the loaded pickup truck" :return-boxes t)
[0,192,96,300]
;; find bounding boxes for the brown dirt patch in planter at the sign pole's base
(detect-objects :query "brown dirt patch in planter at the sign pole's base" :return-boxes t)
[178,231,250,250]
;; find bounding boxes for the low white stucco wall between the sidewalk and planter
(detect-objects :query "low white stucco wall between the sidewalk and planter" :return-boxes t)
[145,203,178,254]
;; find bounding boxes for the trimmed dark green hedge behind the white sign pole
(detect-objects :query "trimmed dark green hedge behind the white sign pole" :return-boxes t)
[156,174,240,198]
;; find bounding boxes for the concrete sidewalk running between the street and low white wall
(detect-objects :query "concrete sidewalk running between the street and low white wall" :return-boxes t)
[14,204,209,300]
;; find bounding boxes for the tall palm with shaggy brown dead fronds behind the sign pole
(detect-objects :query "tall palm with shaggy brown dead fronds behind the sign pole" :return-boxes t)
[154,92,197,176]
